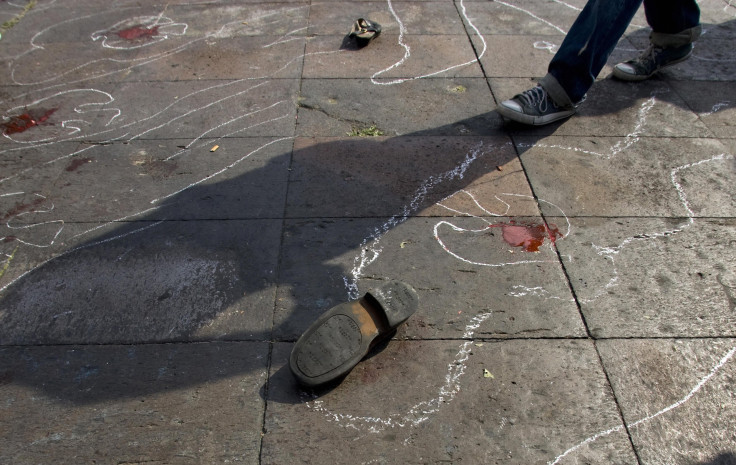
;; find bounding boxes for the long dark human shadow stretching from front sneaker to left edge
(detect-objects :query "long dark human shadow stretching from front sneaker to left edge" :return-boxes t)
[0,114,516,404]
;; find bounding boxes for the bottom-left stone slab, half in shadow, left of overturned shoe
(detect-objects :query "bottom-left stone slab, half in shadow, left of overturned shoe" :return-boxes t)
[0,342,269,464]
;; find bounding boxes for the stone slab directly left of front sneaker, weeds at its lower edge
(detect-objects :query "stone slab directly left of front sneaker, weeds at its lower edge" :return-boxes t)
[297,78,502,137]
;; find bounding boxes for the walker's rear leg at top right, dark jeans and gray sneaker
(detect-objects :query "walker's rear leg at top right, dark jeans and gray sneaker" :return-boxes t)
[613,0,701,81]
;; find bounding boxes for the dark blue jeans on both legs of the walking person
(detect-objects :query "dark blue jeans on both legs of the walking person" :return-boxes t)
[540,0,700,105]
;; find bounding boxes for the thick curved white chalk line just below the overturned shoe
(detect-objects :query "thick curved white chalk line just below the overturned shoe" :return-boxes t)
[306,312,492,433]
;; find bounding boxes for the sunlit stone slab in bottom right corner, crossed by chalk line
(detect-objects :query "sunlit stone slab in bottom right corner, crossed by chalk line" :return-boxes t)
[599,339,736,465]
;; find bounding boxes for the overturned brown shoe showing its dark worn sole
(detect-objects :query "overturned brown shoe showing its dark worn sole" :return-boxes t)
[289,281,418,388]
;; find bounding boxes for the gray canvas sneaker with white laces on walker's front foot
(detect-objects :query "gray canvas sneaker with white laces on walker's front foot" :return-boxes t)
[497,85,577,126]
